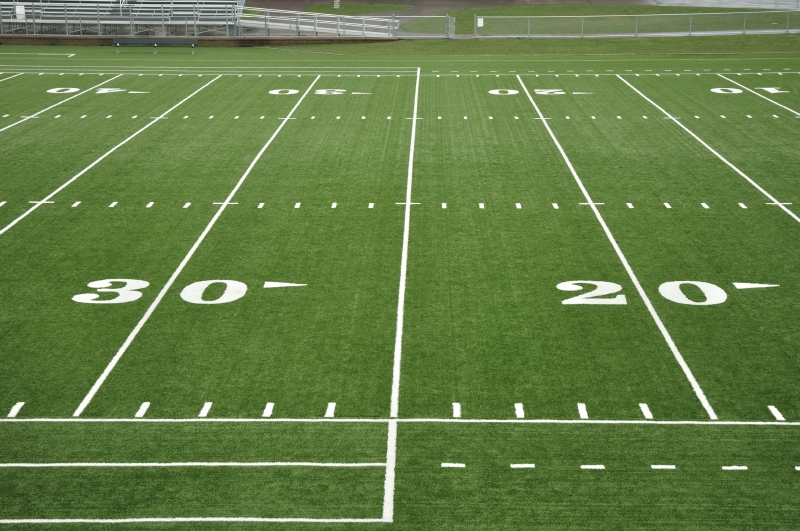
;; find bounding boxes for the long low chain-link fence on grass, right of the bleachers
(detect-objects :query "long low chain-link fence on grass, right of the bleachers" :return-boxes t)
[475,11,800,37]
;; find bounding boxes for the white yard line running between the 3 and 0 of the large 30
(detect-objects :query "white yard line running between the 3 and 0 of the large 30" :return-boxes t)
[72,76,320,417]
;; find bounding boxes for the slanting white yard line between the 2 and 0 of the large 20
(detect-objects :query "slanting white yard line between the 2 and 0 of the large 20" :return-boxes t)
[517,76,717,420]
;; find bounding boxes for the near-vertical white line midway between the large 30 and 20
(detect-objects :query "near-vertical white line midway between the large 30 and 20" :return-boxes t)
[382,68,421,523]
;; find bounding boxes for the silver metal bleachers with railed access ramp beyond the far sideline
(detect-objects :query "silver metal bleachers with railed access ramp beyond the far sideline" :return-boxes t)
[0,0,455,38]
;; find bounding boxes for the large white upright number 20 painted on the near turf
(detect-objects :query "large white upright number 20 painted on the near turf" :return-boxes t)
[556,280,728,306]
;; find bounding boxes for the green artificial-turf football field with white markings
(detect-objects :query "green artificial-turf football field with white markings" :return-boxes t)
[0,46,800,530]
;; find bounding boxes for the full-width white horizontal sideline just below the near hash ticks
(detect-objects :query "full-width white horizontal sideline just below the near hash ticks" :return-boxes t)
[0,417,800,427]
